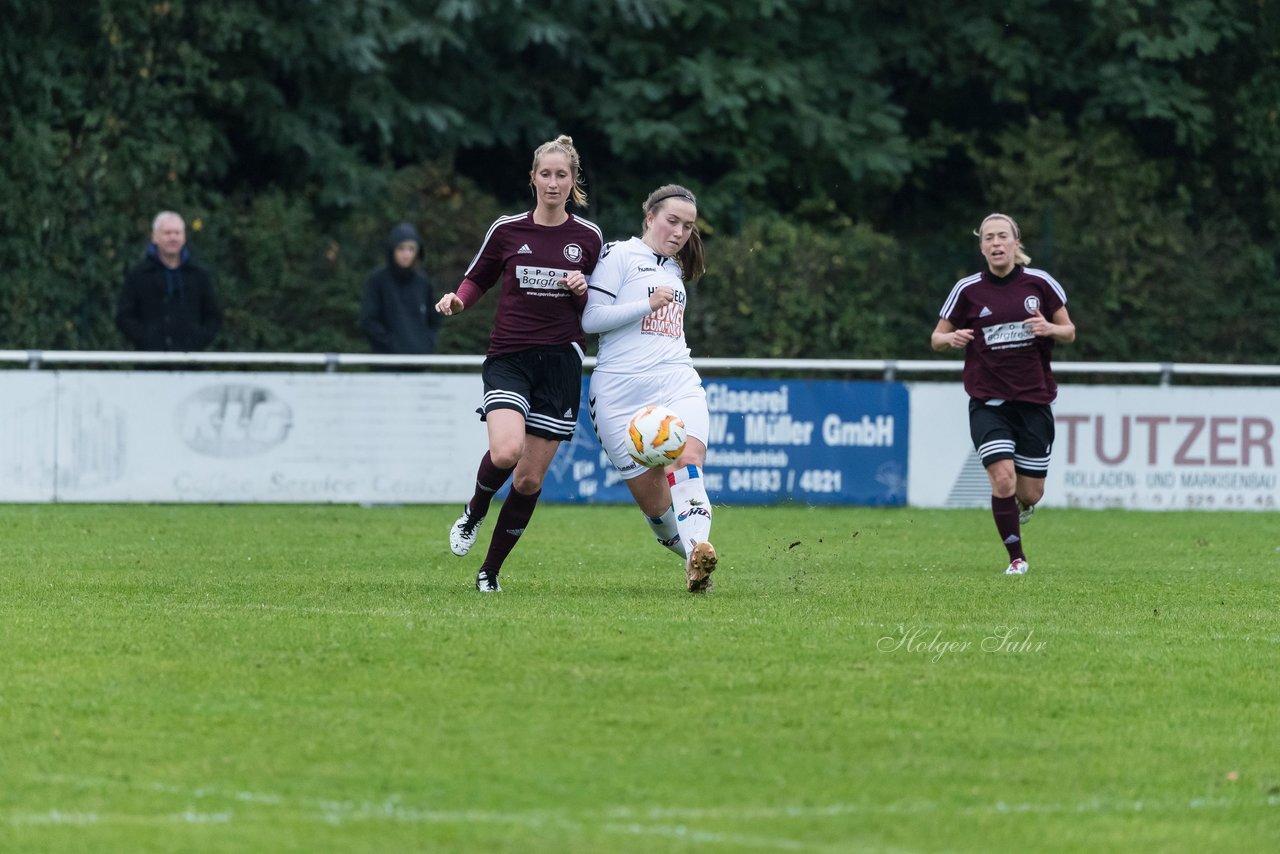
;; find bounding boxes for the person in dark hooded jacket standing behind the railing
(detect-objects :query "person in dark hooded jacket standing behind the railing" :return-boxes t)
[360,223,440,355]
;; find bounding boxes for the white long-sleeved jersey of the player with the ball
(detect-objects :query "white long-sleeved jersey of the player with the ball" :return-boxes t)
[582,237,694,375]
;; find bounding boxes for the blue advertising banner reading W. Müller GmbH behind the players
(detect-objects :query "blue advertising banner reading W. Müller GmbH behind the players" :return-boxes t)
[541,379,909,507]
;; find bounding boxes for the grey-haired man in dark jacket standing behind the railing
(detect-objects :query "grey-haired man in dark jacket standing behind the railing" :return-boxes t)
[115,210,223,351]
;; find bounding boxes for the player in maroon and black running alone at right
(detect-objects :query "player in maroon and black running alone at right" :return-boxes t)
[931,214,1075,575]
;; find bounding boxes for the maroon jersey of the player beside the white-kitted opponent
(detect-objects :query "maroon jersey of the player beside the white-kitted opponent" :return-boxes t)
[458,211,603,356]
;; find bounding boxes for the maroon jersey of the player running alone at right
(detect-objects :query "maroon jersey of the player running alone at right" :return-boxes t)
[938,266,1066,403]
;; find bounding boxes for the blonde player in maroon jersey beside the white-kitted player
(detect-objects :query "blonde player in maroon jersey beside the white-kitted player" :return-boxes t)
[435,134,603,593]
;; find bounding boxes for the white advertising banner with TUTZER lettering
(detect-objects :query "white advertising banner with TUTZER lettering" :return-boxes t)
[908,383,1280,510]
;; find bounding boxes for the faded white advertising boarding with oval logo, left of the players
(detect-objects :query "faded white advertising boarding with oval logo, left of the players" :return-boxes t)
[0,371,488,503]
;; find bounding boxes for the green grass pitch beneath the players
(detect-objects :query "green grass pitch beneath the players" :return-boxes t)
[0,506,1280,853]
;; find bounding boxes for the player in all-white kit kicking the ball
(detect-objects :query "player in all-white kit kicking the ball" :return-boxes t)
[582,184,717,593]
